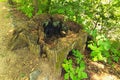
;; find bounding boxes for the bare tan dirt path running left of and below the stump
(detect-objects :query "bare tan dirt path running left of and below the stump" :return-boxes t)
[0,2,52,80]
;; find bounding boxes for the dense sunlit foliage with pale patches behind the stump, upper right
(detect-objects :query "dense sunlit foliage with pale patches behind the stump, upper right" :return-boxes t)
[49,0,120,39]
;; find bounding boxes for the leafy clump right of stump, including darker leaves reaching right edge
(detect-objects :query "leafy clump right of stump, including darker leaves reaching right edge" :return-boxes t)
[88,33,120,63]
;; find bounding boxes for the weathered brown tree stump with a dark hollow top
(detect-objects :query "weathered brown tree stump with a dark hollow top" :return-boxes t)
[9,14,87,76]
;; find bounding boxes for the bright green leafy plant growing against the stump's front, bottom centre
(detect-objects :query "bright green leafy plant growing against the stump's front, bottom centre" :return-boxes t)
[62,50,87,80]
